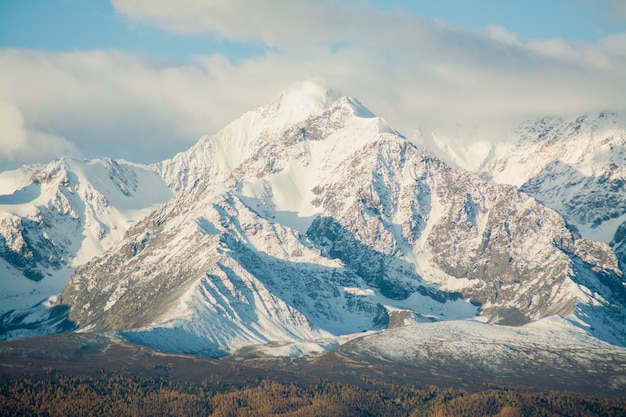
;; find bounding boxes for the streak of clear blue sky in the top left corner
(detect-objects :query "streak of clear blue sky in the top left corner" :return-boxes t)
[0,0,263,62]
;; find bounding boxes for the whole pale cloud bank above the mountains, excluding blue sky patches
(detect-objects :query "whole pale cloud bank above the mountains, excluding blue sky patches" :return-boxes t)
[0,0,626,169]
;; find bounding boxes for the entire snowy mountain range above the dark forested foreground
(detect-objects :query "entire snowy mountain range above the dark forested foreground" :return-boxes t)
[0,82,626,390]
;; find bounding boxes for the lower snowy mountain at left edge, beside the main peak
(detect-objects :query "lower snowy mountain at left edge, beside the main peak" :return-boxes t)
[0,158,172,338]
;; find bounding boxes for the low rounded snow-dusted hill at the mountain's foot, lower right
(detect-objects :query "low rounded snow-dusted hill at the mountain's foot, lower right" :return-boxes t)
[316,316,626,396]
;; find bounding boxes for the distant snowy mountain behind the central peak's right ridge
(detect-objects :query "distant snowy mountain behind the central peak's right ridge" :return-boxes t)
[419,112,626,268]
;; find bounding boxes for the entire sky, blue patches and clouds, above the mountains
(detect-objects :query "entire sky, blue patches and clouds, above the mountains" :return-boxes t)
[0,0,626,171]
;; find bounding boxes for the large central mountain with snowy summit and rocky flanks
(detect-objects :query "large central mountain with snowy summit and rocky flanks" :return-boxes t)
[59,85,626,354]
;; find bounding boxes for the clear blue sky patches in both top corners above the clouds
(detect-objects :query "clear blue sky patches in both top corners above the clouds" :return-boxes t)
[0,0,625,62]
